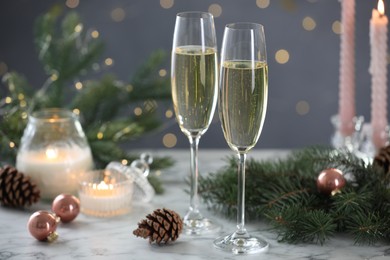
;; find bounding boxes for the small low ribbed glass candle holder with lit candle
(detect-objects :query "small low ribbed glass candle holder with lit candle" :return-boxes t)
[79,169,133,217]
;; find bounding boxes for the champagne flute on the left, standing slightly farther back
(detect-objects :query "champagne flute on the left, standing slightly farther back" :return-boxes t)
[171,12,218,235]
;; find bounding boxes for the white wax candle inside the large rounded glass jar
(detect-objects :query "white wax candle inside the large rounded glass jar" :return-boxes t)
[16,147,93,199]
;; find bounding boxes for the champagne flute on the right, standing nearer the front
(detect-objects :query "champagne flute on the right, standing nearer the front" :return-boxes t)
[214,23,268,254]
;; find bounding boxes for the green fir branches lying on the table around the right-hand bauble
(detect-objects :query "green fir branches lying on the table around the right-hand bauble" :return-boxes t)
[199,147,390,244]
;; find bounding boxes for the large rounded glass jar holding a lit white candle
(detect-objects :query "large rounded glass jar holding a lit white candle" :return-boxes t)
[16,108,93,200]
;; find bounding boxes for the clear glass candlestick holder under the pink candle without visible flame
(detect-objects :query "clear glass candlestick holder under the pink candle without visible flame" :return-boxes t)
[331,115,364,152]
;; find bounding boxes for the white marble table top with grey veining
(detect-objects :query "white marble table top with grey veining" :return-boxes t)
[0,149,390,260]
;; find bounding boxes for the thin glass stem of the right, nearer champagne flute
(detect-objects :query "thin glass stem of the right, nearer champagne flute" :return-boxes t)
[237,153,246,234]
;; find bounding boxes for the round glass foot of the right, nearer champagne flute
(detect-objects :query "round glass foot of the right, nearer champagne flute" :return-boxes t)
[214,231,269,255]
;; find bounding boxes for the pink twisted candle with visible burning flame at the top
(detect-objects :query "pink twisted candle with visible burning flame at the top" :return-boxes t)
[369,0,388,148]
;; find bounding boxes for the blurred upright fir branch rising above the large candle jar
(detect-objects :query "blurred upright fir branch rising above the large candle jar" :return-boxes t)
[34,6,103,107]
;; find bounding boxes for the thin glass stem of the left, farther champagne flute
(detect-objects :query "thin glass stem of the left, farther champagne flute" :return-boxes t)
[189,136,200,214]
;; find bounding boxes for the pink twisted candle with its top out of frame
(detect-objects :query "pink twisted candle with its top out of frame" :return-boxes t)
[339,0,355,136]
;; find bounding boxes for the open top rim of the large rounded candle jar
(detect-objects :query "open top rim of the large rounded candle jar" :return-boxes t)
[29,108,78,123]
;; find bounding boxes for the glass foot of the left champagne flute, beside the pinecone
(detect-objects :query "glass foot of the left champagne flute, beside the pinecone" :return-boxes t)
[183,218,221,236]
